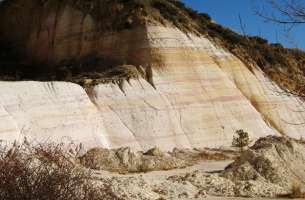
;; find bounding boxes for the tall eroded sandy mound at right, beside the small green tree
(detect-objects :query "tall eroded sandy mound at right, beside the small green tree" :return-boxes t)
[170,136,305,197]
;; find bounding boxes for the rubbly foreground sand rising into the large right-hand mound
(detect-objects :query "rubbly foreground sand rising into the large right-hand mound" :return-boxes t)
[91,136,305,199]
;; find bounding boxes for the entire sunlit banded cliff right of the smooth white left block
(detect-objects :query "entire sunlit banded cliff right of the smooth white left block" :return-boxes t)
[89,26,304,148]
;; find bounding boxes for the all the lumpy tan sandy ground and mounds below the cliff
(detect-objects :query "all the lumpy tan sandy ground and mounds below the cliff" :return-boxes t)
[3,136,305,200]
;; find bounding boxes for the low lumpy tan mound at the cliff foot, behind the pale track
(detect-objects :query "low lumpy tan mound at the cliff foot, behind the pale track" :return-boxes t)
[80,148,189,173]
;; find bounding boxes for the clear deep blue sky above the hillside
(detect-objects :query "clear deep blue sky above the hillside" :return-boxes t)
[182,0,305,49]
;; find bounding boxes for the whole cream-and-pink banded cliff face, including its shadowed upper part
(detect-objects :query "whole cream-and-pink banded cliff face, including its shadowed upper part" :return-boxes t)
[0,1,305,149]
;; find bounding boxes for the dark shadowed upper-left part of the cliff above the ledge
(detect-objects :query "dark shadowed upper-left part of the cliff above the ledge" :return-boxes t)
[0,0,147,64]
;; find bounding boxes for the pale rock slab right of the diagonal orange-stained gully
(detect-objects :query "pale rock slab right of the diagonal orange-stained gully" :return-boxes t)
[214,55,305,138]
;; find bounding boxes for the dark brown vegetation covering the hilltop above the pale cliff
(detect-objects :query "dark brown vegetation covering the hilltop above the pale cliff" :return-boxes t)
[0,0,305,96]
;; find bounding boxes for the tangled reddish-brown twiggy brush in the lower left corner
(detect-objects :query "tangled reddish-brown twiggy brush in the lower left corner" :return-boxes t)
[0,143,118,200]
